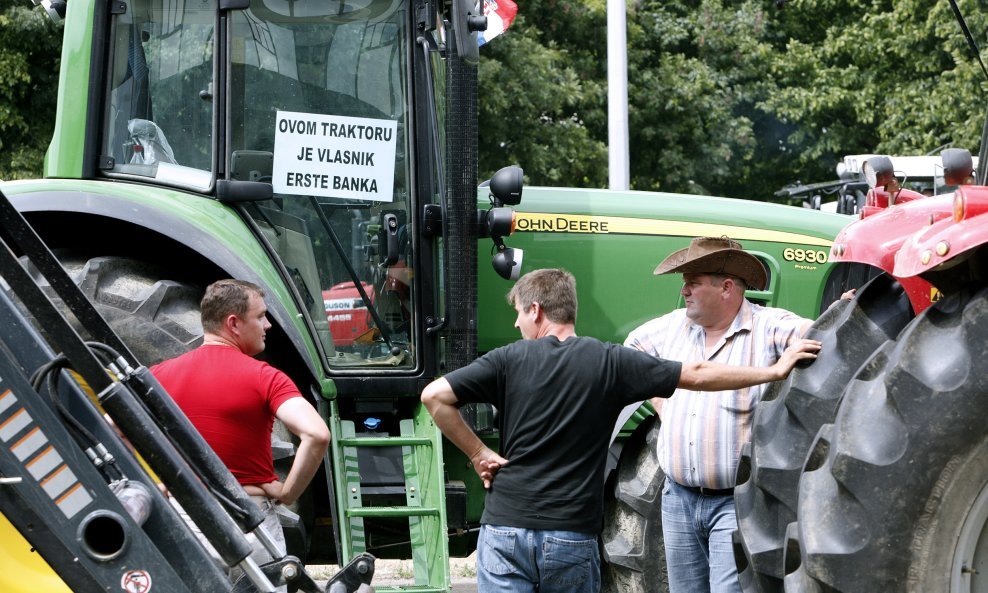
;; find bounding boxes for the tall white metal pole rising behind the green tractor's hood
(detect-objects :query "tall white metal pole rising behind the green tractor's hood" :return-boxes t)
[607,0,631,190]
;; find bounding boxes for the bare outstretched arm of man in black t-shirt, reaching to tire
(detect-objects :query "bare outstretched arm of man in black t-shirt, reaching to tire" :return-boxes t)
[678,339,822,391]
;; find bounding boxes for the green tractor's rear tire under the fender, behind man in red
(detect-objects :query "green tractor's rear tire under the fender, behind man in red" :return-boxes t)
[19,255,203,366]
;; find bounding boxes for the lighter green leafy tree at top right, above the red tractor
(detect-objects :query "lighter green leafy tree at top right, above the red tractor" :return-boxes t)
[760,0,988,190]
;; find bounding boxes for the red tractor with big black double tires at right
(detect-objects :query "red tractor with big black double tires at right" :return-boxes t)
[735,149,988,592]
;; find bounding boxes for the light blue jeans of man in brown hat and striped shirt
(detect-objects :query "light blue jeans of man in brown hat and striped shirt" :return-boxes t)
[662,478,741,593]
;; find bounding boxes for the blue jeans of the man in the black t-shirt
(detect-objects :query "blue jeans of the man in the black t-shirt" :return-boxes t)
[477,525,600,593]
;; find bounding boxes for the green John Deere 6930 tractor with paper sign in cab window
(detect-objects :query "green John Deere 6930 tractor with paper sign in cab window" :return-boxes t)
[0,0,848,591]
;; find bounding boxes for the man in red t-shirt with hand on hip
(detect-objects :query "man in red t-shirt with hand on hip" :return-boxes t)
[151,280,329,584]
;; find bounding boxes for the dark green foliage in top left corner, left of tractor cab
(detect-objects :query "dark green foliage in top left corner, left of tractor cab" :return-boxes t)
[0,0,61,180]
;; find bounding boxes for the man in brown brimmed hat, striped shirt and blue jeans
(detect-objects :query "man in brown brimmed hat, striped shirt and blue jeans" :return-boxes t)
[625,237,812,593]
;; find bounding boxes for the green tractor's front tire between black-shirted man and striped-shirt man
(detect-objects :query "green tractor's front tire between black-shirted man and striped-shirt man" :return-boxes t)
[601,416,669,593]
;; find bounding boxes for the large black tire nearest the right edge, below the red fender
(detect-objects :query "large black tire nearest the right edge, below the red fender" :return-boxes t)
[785,290,988,593]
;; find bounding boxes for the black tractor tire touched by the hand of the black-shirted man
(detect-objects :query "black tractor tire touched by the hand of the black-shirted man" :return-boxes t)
[734,274,913,593]
